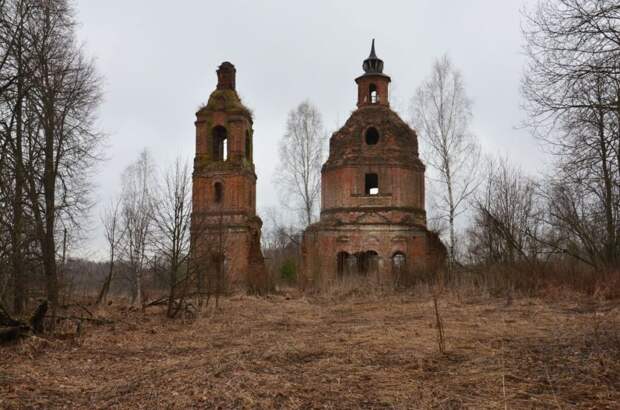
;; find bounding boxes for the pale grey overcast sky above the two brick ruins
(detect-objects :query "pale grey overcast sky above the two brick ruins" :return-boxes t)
[74,0,544,257]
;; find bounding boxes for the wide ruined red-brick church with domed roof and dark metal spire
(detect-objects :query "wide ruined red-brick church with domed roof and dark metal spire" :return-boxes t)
[302,41,445,284]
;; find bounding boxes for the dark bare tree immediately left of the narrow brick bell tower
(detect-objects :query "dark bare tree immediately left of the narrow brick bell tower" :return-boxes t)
[154,158,192,318]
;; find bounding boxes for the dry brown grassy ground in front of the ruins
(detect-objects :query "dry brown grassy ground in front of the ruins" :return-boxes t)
[0,294,620,409]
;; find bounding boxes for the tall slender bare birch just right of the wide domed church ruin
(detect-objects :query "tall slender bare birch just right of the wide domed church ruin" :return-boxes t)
[411,56,479,262]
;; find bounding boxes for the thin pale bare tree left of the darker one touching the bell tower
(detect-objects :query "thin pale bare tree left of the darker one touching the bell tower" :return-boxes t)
[121,150,155,306]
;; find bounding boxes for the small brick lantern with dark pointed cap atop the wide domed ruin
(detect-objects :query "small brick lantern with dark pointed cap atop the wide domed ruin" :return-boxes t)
[355,39,391,107]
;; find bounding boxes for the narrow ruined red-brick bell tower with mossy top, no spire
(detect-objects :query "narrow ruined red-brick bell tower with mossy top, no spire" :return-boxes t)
[192,61,264,286]
